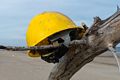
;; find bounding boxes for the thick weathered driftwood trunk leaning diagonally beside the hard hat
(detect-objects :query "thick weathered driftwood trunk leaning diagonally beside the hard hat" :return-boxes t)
[48,10,120,80]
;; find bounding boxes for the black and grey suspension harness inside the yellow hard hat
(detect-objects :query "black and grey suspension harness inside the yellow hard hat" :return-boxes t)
[41,29,82,63]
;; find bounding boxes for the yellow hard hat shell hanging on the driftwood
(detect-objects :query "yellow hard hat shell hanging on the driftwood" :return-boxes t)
[26,11,82,56]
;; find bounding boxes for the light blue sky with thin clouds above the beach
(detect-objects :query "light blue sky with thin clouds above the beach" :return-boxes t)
[0,0,120,46]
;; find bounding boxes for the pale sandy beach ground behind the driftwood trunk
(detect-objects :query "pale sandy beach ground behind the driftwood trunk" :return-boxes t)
[0,51,120,80]
